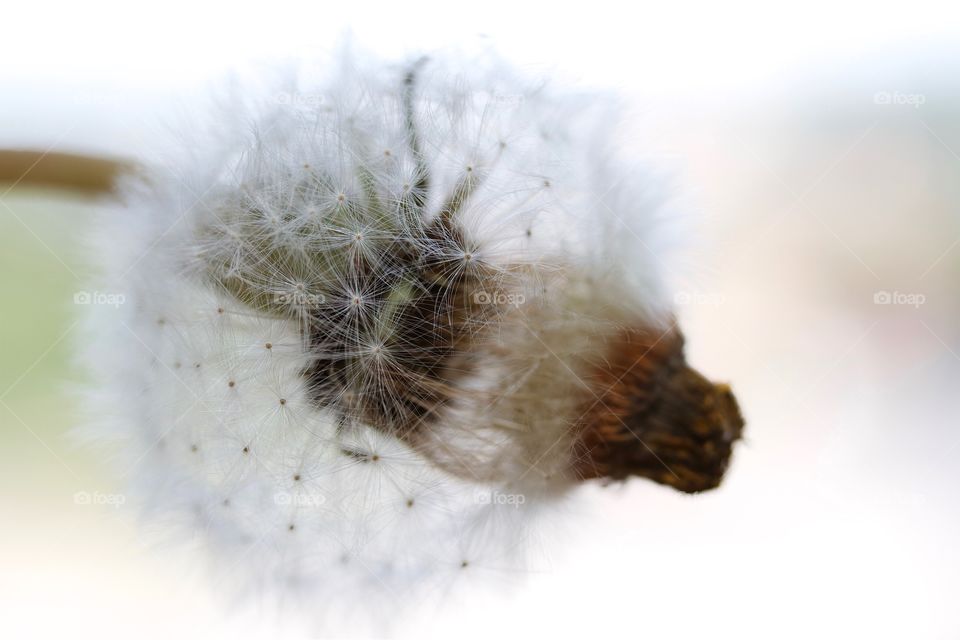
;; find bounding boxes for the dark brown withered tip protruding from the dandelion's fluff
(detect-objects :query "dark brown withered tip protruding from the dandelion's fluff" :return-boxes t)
[575,330,744,493]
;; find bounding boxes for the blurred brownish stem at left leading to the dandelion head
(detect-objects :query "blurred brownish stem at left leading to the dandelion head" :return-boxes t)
[0,149,134,195]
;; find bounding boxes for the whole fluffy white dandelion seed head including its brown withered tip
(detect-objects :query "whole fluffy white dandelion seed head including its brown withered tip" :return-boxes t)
[80,48,742,624]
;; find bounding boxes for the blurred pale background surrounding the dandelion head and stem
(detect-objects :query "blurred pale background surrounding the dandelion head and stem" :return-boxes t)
[0,2,960,638]
